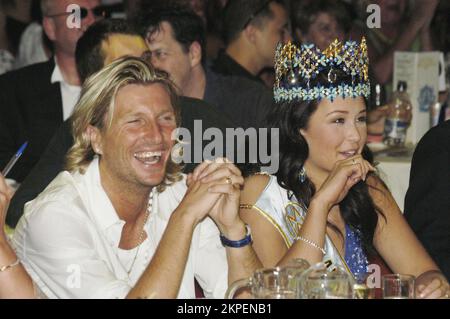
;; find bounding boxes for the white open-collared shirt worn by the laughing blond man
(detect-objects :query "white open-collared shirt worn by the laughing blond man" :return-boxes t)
[13,159,228,299]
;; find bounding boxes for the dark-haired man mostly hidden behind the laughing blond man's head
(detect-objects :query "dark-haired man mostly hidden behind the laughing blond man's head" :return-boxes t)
[6,19,233,227]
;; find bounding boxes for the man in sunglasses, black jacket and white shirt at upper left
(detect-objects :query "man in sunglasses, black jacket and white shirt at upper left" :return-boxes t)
[0,0,101,183]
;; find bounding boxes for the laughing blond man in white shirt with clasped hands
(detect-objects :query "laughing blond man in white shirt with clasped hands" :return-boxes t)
[13,57,261,298]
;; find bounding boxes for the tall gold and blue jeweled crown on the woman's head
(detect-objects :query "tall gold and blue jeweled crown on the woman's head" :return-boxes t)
[274,37,370,102]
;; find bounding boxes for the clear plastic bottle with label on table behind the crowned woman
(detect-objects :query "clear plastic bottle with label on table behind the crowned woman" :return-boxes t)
[383,81,412,147]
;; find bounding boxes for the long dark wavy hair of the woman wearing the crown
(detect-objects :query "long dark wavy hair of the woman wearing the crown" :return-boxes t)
[267,70,384,253]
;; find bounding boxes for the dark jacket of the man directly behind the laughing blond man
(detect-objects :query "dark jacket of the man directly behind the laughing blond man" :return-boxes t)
[6,97,234,227]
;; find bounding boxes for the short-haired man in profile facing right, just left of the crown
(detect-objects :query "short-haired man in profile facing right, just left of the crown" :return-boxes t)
[213,0,289,81]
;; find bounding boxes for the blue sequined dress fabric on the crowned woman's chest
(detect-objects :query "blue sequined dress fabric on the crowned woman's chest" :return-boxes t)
[345,224,369,277]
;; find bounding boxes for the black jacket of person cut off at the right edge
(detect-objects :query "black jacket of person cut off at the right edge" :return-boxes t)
[404,120,450,280]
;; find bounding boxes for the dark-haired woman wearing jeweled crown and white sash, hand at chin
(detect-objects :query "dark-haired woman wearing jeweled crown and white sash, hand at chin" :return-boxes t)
[240,38,448,298]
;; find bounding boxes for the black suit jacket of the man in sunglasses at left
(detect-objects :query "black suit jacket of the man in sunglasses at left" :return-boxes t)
[0,59,63,182]
